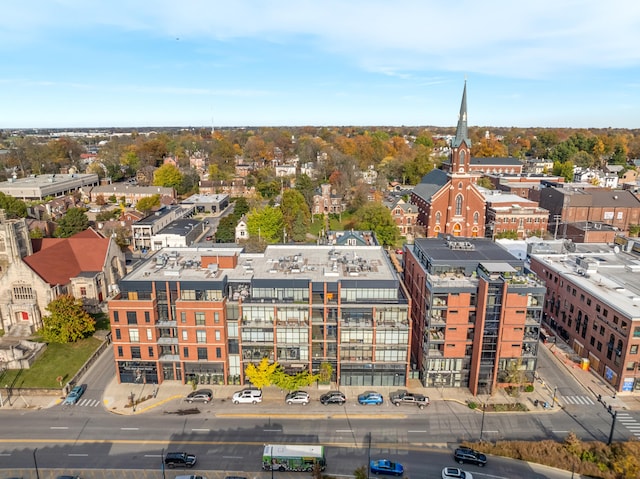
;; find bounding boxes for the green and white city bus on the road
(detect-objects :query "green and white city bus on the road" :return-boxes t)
[262,444,327,472]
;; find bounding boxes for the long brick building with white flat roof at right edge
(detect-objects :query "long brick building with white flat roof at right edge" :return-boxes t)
[530,237,640,394]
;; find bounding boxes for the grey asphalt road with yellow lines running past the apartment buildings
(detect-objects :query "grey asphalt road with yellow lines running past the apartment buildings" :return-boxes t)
[0,340,640,479]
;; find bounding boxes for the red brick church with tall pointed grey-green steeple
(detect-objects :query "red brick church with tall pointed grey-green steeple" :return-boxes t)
[411,82,486,238]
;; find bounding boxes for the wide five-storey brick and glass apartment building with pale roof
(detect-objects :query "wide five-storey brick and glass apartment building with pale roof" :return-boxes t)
[109,245,411,386]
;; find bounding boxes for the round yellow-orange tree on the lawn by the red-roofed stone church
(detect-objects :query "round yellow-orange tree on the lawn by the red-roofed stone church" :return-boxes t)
[42,295,96,344]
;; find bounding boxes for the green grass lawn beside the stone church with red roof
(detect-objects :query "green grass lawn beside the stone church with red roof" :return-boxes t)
[0,337,101,388]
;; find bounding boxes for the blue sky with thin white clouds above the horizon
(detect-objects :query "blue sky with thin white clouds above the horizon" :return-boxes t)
[0,0,640,128]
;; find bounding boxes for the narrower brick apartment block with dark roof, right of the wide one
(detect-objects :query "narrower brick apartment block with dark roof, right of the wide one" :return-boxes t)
[404,236,545,395]
